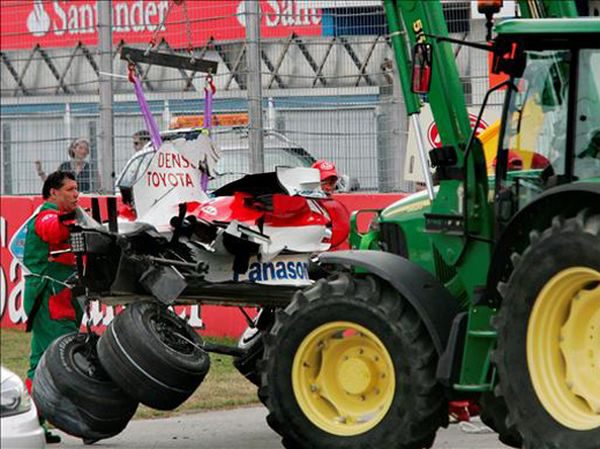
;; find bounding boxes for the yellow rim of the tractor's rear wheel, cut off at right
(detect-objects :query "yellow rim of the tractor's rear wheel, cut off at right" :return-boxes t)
[527,267,600,431]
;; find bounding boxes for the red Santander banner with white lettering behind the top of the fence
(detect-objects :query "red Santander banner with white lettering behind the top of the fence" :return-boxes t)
[0,0,321,51]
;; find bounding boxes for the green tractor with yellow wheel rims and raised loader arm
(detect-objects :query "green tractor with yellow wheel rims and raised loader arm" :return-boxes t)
[259,0,600,449]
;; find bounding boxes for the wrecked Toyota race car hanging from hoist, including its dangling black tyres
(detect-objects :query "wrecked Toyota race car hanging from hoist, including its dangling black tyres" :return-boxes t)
[31,127,347,439]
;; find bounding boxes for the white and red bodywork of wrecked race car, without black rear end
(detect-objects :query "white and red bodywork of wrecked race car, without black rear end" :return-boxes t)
[103,126,349,294]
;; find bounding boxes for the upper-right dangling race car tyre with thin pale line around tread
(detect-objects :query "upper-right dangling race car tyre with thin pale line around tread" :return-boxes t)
[98,303,210,410]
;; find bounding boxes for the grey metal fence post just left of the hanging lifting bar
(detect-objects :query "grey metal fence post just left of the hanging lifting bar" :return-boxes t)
[96,0,115,193]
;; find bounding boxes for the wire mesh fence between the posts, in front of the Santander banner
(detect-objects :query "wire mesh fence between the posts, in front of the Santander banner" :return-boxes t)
[0,0,564,194]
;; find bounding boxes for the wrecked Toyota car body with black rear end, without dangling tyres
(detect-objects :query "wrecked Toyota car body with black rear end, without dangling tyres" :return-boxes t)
[79,128,348,305]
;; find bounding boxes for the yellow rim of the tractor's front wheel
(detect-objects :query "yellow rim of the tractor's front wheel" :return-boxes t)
[292,321,396,436]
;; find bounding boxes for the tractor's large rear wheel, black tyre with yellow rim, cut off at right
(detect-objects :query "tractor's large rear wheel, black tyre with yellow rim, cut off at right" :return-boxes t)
[494,210,600,449]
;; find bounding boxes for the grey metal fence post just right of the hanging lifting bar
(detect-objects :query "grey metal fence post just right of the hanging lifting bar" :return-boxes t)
[244,0,265,173]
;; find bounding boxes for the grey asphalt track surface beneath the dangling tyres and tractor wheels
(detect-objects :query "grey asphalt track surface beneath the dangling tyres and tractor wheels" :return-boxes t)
[57,407,508,449]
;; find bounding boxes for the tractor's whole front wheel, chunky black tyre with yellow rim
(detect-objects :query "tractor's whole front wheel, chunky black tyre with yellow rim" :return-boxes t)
[259,274,448,449]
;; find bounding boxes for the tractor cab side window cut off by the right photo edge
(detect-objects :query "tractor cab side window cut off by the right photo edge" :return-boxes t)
[574,49,600,179]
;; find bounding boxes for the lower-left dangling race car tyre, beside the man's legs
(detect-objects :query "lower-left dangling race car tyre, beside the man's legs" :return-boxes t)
[32,334,138,440]
